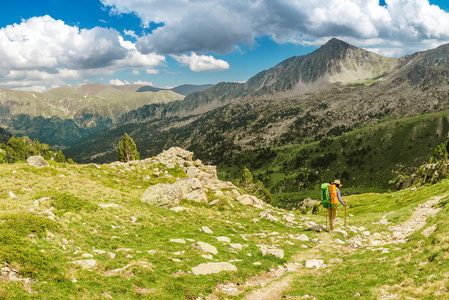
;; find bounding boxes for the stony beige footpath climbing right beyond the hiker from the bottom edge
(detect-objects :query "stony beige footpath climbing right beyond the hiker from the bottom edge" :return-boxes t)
[228,196,445,300]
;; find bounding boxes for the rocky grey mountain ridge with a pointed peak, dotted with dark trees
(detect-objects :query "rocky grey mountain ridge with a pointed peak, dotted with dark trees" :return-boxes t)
[67,39,449,171]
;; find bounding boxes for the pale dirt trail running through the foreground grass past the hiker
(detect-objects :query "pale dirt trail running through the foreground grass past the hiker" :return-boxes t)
[207,195,440,300]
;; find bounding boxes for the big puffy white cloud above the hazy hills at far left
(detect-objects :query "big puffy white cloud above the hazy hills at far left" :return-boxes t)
[0,16,165,89]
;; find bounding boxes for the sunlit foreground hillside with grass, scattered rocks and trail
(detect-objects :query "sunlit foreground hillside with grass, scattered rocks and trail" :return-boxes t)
[0,149,449,299]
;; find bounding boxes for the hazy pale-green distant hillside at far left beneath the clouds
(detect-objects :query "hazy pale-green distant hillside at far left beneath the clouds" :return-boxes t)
[0,83,184,148]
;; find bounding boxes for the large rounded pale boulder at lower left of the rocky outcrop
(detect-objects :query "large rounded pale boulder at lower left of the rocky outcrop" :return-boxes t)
[140,183,183,207]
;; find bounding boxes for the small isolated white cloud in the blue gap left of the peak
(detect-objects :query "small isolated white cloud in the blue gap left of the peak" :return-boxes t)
[172,52,229,72]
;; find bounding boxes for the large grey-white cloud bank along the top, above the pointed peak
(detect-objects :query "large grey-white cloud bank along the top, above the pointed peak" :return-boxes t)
[100,0,449,55]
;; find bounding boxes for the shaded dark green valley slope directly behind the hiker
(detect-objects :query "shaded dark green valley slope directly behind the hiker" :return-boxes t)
[218,111,449,206]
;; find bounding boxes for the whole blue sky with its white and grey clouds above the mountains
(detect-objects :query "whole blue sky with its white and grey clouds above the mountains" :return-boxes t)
[0,0,449,91]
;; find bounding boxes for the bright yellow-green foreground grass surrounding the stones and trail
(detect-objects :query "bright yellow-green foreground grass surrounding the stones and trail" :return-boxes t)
[0,157,449,299]
